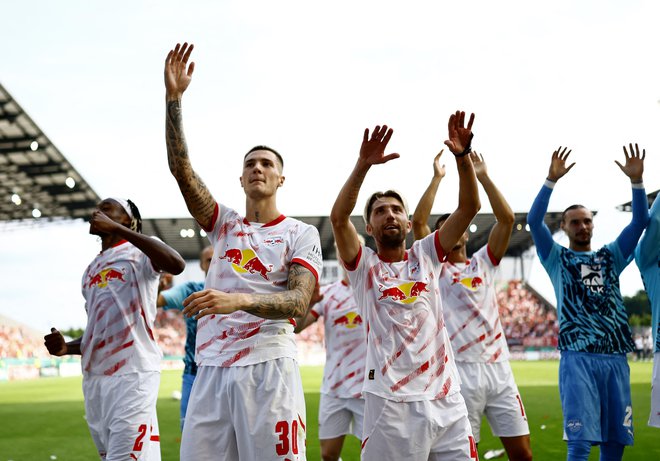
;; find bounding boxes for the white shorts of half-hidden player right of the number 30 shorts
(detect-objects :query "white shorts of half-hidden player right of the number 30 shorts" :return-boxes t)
[319,394,364,440]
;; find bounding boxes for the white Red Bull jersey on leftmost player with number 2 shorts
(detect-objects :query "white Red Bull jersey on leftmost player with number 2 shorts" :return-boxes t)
[81,240,162,376]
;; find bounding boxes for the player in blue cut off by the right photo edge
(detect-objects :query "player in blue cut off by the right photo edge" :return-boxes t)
[635,190,660,427]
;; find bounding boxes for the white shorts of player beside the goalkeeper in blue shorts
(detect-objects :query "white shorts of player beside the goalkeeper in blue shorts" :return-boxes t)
[456,361,529,443]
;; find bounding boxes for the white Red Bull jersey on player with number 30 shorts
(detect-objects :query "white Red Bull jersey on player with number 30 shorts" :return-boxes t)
[201,204,322,367]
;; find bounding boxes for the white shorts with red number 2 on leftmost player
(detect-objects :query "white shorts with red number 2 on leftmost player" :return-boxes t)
[83,371,160,461]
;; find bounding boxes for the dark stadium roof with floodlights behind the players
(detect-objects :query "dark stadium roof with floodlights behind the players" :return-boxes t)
[0,84,561,260]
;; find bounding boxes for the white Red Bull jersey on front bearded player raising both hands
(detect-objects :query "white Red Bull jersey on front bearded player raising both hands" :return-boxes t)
[349,232,460,402]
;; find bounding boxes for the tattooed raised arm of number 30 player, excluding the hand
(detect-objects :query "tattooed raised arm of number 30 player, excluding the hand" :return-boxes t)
[165,100,215,229]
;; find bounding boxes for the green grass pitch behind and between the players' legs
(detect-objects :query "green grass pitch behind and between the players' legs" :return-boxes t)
[0,362,660,461]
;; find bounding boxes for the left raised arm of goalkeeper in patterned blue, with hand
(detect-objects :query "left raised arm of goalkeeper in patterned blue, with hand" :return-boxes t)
[527,146,575,259]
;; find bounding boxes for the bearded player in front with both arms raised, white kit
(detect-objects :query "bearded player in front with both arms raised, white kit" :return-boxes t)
[330,112,480,461]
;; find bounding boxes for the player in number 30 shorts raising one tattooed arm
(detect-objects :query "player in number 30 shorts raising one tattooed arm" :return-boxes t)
[165,43,322,461]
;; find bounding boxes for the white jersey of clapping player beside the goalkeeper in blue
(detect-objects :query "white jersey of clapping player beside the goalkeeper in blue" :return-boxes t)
[440,245,509,363]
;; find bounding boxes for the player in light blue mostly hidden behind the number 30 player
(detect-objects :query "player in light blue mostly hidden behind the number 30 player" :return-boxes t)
[157,245,213,431]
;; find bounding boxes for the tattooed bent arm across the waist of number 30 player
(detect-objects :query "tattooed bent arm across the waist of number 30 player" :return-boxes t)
[245,264,316,320]
